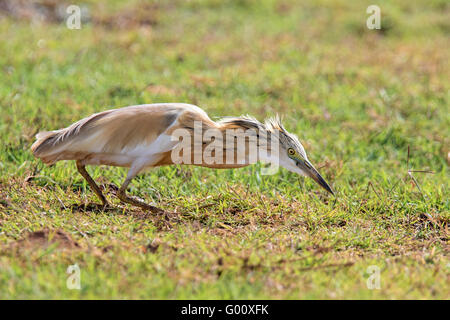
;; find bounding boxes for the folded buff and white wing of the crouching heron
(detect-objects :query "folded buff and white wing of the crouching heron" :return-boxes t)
[32,104,211,163]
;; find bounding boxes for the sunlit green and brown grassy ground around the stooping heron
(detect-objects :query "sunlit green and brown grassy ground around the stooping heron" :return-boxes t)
[0,0,450,299]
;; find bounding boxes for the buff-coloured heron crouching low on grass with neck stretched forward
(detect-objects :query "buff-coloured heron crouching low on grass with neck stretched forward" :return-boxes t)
[31,103,334,212]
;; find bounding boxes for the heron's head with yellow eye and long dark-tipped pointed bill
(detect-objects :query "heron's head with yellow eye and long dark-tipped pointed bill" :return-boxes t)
[265,117,334,195]
